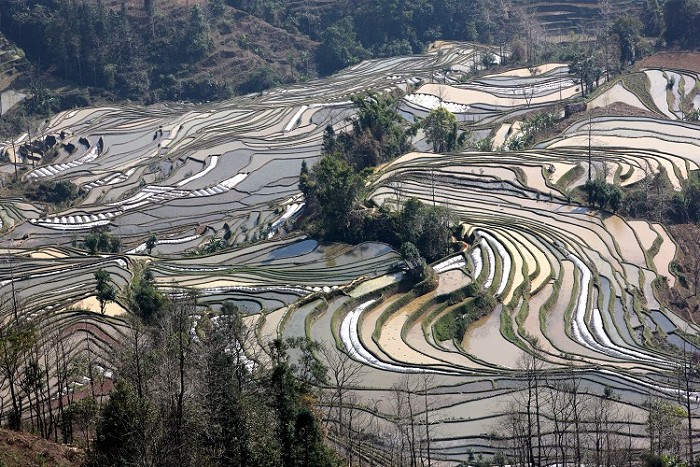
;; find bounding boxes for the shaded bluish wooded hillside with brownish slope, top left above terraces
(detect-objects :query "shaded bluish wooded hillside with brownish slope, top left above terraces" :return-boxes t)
[0,0,316,102]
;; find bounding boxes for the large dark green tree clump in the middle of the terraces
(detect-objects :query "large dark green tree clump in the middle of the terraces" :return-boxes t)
[299,95,454,261]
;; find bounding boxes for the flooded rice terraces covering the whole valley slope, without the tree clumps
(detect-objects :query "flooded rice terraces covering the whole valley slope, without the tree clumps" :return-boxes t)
[0,43,700,465]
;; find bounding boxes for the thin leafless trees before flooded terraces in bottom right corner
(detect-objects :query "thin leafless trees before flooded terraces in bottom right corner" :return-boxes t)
[498,342,699,467]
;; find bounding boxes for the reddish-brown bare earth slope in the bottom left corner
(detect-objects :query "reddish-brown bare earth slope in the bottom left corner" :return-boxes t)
[0,429,84,467]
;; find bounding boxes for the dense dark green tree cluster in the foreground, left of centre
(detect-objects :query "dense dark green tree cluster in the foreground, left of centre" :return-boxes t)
[85,295,337,467]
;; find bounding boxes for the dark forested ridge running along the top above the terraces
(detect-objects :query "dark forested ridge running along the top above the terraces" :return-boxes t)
[0,0,700,110]
